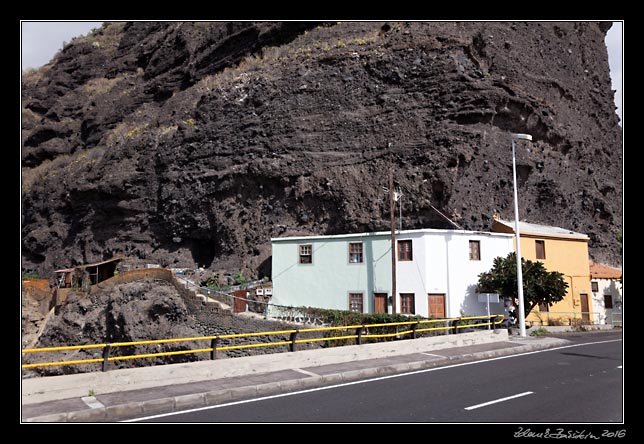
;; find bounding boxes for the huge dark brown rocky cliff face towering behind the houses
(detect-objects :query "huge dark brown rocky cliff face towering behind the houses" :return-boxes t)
[22,22,623,277]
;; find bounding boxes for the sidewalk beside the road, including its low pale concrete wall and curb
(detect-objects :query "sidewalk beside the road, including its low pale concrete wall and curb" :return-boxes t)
[21,330,569,422]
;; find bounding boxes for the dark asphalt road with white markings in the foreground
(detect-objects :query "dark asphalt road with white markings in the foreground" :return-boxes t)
[137,334,624,424]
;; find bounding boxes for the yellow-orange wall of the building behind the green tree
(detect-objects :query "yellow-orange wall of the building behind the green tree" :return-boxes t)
[515,233,594,325]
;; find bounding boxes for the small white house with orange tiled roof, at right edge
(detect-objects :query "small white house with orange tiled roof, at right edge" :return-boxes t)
[590,261,622,325]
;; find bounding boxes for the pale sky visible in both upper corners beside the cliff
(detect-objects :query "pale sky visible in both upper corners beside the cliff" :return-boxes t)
[21,22,624,121]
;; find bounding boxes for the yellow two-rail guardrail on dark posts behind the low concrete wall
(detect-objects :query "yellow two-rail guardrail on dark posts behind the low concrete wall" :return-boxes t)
[22,314,504,372]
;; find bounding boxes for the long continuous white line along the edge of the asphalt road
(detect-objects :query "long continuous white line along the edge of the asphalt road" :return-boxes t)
[121,339,621,422]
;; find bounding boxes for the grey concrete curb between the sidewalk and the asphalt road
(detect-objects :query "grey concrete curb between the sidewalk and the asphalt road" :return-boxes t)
[23,338,570,422]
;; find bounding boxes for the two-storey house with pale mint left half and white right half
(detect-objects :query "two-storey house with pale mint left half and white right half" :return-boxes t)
[269,229,514,318]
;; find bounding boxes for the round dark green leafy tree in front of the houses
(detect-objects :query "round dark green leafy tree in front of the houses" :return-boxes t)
[477,252,568,316]
